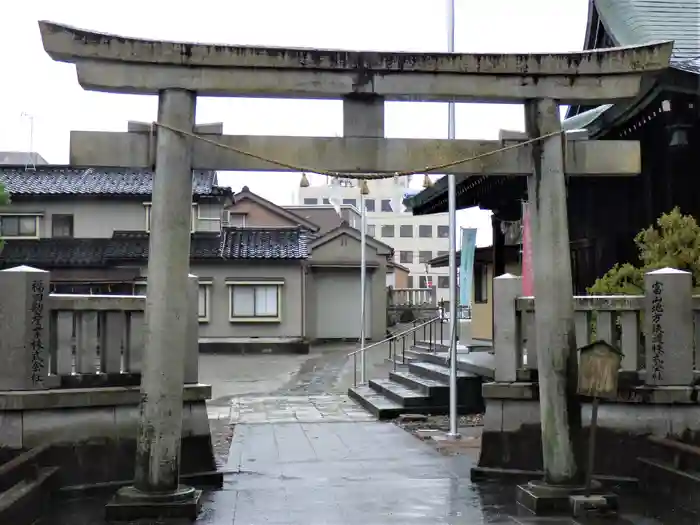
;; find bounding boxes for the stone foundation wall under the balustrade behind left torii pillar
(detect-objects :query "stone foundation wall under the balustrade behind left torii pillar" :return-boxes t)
[0,385,216,487]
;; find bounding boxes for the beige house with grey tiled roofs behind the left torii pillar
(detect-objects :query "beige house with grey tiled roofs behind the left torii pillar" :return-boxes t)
[0,165,392,352]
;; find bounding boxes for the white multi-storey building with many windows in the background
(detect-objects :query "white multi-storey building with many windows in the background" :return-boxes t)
[298,177,449,301]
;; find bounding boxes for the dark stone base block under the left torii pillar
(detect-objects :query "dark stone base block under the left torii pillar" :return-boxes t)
[105,486,202,522]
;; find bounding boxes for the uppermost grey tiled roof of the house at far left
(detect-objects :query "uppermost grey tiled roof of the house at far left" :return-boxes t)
[0,165,220,196]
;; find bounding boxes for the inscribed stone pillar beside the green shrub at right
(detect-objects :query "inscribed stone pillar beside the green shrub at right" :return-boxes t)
[644,268,693,386]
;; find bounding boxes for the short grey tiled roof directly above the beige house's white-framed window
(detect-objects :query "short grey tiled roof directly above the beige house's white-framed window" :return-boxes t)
[219,228,309,259]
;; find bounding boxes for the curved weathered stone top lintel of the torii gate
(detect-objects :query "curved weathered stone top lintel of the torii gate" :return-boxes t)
[39,21,673,103]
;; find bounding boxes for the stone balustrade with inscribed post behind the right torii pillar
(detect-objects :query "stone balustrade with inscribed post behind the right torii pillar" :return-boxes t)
[494,268,700,386]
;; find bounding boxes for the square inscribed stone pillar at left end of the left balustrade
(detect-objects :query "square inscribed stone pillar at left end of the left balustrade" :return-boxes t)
[0,266,50,390]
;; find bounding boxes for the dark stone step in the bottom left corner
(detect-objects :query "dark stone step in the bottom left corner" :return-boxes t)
[0,467,59,525]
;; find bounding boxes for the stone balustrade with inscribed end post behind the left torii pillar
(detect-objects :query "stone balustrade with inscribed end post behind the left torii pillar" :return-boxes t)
[0,267,199,391]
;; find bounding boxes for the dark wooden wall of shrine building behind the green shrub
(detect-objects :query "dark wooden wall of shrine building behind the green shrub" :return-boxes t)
[568,95,700,293]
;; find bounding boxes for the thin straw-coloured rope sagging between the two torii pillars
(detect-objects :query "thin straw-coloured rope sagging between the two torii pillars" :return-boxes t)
[153,122,565,180]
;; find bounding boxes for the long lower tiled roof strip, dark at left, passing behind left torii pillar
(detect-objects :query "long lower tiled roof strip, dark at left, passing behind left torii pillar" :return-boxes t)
[0,228,309,268]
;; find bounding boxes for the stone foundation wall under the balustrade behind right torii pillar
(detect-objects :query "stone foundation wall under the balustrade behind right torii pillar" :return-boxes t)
[479,383,700,478]
